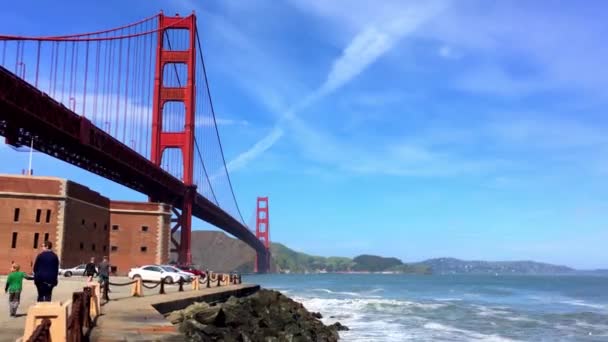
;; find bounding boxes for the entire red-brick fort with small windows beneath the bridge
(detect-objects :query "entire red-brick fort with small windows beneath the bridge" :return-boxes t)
[0,174,171,274]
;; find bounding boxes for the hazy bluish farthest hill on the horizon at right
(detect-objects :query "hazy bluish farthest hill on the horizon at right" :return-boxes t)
[419,258,576,274]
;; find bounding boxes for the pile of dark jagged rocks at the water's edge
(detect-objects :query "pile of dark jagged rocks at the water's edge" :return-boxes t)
[168,289,348,342]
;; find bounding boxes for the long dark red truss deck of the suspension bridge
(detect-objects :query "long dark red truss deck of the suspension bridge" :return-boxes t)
[0,66,266,255]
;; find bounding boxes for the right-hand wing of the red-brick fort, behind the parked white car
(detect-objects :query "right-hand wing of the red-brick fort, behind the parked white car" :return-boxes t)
[110,201,171,274]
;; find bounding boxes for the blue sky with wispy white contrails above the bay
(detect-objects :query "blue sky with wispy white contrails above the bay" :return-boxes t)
[0,0,608,268]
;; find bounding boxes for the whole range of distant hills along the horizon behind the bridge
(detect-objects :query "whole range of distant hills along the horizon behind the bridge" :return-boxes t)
[176,231,608,276]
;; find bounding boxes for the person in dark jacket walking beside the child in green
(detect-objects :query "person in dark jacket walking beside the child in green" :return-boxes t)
[34,241,59,302]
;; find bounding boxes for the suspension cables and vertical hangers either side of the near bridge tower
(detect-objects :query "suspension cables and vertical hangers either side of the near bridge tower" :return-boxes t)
[0,15,246,225]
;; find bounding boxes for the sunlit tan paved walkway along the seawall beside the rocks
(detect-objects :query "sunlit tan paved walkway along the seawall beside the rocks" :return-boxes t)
[0,276,259,342]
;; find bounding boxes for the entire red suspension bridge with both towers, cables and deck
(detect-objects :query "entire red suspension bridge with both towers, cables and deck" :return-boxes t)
[0,12,270,272]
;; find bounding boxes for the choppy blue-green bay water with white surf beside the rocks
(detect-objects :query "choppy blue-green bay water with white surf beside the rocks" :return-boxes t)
[244,274,608,341]
